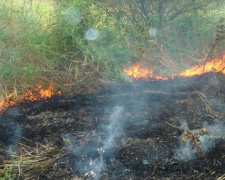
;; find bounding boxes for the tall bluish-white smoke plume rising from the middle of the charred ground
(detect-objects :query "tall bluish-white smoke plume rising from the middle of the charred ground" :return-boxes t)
[67,106,124,179]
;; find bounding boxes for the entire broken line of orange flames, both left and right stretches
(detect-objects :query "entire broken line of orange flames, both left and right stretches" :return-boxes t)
[0,55,225,112]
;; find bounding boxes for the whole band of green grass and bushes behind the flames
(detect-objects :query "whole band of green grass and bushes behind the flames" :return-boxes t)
[0,0,225,98]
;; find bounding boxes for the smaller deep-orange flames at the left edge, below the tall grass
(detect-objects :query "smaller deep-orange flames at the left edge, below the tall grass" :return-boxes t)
[0,83,61,112]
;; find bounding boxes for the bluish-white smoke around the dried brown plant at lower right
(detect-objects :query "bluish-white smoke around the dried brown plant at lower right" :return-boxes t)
[173,121,225,161]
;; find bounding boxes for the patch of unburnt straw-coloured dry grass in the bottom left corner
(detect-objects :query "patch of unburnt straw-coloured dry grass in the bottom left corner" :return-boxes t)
[0,139,67,180]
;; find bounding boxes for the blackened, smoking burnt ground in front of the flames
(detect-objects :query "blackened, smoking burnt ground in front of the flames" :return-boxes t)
[0,73,225,180]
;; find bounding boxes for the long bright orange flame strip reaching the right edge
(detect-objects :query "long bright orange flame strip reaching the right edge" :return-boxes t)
[123,55,225,80]
